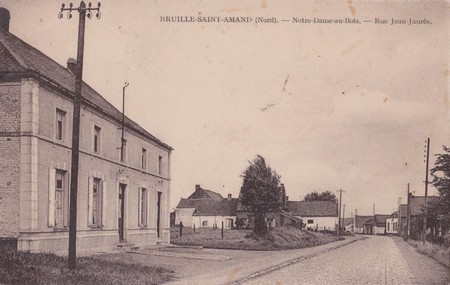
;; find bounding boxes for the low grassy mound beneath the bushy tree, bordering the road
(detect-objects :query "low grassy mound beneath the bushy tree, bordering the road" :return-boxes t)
[171,227,344,250]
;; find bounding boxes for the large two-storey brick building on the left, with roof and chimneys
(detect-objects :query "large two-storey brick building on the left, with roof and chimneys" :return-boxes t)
[0,13,172,252]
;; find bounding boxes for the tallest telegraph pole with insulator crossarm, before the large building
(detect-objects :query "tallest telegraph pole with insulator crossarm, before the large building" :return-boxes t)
[58,1,101,269]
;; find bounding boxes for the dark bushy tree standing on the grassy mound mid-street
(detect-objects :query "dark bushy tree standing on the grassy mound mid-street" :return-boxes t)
[240,155,283,236]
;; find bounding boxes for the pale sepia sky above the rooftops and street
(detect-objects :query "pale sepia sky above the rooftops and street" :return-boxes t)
[0,0,450,216]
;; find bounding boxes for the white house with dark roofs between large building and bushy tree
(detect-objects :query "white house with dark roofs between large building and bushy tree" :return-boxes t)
[175,185,238,229]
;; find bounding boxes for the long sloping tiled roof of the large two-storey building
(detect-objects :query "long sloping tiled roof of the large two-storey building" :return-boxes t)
[0,29,172,150]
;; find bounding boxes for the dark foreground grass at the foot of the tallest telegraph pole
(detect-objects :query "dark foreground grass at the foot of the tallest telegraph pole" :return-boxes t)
[0,244,173,284]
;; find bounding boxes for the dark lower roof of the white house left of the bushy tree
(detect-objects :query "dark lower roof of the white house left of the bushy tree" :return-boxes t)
[177,198,238,216]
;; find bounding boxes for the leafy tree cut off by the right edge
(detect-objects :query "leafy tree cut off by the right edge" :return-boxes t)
[430,145,450,234]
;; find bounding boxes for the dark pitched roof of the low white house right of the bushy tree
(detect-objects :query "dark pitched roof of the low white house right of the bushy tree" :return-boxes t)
[287,201,338,217]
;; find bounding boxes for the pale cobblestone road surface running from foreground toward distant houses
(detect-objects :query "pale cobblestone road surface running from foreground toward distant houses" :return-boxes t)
[244,236,445,285]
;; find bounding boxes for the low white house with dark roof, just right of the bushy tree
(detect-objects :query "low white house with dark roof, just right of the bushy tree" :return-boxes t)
[287,201,338,231]
